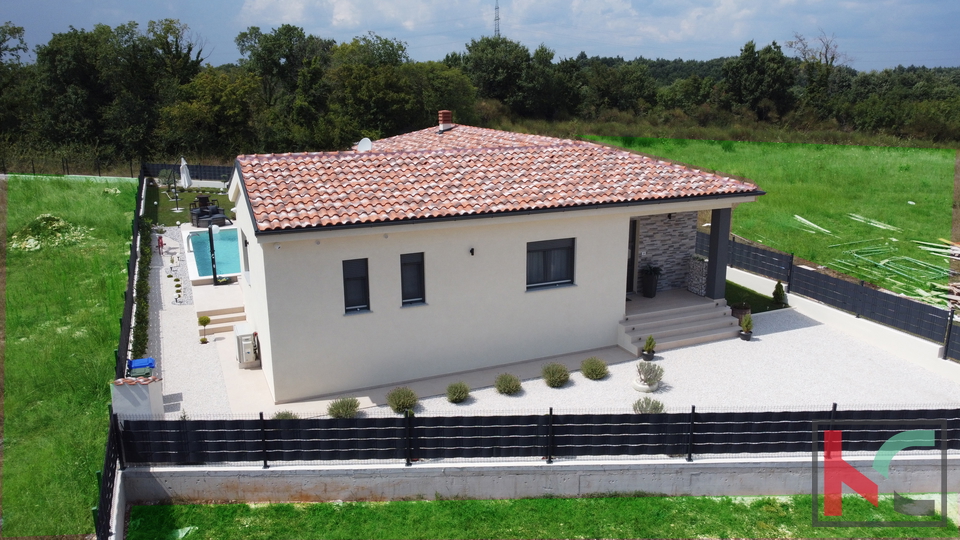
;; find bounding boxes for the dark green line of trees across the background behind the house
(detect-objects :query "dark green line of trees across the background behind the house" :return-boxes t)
[0,19,960,167]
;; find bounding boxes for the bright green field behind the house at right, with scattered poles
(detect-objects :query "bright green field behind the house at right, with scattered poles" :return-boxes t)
[588,137,955,302]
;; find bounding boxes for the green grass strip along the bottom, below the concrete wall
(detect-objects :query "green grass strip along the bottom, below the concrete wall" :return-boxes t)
[127,495,957,540]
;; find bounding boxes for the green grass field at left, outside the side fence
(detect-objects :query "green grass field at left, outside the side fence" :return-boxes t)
[3,176,137,537]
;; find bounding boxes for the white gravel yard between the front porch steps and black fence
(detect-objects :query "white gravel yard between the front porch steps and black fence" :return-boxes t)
[378,309,960,415]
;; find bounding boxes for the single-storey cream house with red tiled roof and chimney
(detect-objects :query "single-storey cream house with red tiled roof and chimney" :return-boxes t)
[230,111,763,403]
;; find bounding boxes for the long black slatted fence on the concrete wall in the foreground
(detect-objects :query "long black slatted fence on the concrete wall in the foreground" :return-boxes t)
[121,409,960,466]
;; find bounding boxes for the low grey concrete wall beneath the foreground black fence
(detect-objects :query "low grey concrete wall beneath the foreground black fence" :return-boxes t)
[122,456,960,504]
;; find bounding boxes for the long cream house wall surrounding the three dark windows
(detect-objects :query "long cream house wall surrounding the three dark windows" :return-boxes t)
[260,213,629,402]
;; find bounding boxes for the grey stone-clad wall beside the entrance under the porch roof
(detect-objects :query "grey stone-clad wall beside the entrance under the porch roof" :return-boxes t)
[636,212,697,291]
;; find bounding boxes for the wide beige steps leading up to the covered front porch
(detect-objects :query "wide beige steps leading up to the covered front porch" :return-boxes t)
[617,298,740,356]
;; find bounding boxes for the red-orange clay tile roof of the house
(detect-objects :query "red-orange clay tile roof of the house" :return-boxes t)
[237,125,763,231]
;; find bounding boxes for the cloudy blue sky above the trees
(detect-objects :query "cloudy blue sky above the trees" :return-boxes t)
[0,0,960,70]
